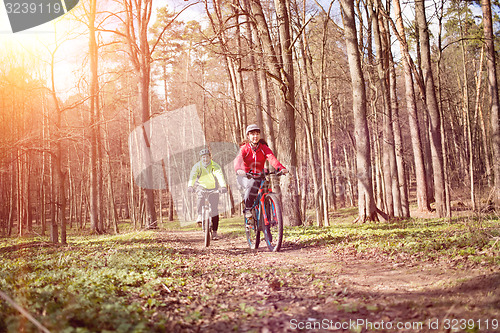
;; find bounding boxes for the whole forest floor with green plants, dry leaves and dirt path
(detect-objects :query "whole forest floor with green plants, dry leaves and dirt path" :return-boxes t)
[0,209,500,333]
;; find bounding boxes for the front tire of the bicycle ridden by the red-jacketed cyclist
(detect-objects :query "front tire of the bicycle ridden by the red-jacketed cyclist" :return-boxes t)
[262,193,283,252]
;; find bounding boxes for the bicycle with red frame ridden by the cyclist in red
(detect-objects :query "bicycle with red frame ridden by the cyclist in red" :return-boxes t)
[245,170,283,252]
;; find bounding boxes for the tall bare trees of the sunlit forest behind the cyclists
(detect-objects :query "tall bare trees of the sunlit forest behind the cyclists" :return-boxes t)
[0,1,499,237]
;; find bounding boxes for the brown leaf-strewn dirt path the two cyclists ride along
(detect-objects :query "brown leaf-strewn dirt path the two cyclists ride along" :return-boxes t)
[154,231,500,332]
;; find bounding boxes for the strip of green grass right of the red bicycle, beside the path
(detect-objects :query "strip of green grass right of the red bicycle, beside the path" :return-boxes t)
[285,216,500,265]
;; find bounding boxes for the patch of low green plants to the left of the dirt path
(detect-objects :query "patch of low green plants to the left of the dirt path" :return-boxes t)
[0,231,195,332]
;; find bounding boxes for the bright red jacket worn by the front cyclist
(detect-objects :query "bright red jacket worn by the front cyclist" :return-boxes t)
[234,143,285,173]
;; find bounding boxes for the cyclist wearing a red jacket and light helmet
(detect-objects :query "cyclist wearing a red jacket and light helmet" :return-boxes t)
[234,125,288,218]
